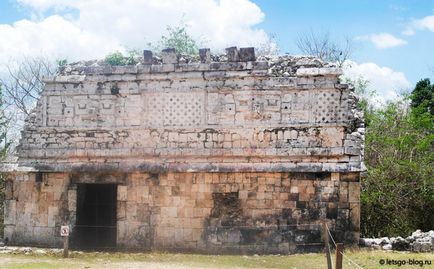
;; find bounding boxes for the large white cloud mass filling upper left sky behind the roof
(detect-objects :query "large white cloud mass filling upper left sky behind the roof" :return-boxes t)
[0,0,269,63]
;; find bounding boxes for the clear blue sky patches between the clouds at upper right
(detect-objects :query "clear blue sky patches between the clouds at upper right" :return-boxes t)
[254,0,434,83]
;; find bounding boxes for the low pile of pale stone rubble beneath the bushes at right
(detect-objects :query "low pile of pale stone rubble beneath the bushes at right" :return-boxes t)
[360,230,434,252]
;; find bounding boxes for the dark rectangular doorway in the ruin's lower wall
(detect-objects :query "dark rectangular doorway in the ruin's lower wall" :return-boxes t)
[72,184,117,249]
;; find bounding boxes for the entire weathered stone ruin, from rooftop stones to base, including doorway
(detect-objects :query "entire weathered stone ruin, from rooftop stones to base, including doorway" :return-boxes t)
[5,48,364,253]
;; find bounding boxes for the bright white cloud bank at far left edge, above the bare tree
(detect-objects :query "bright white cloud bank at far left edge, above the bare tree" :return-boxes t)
[0,15,120,64]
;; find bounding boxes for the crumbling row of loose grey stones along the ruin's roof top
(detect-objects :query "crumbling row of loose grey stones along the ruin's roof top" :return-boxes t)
[56,47,342,77]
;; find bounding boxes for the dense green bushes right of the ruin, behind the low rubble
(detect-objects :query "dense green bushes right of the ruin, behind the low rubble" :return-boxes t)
[361,99,434,236]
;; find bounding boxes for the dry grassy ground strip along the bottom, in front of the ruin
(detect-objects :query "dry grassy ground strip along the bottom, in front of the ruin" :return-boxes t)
[0,250,434,269]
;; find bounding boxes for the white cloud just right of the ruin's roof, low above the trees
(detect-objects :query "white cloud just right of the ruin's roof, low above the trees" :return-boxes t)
[343,61,412,103]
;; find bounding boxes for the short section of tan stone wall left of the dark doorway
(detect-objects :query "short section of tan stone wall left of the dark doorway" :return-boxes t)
[4,173,73,247]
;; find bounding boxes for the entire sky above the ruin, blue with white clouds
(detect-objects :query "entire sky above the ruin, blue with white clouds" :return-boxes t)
[0,0,434,99]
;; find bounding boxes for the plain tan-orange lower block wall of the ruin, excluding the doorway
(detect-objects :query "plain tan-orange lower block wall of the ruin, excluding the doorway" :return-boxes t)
[5,172,360,253]
